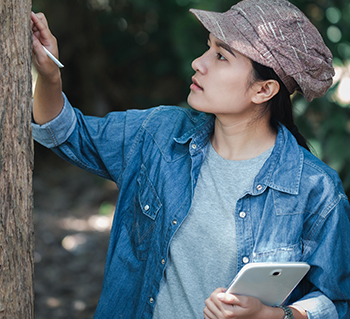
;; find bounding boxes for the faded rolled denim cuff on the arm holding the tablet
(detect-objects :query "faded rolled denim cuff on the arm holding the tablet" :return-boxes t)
[291,291,339,319]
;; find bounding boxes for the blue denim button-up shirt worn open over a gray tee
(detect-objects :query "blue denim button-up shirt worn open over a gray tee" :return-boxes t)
[32,98,350,319]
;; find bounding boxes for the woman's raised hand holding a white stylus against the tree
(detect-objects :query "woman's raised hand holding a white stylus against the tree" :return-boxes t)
[31,12,60,80]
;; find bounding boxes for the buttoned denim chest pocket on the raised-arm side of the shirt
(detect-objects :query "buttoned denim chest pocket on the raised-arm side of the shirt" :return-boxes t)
[126,165,162,260]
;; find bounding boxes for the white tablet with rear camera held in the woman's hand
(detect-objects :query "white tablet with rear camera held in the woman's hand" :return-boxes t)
[227,262,310,306]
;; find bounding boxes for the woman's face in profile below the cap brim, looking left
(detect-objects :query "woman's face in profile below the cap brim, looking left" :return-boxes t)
[188,34,256,120]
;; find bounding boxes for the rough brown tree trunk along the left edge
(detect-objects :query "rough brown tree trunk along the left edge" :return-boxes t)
[0,0,34,319]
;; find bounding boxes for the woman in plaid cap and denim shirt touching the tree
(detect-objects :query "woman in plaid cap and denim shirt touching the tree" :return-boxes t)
[32,0,350,319]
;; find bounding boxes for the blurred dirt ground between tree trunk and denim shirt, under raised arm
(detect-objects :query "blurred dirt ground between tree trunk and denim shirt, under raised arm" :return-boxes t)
[33,145,118,319]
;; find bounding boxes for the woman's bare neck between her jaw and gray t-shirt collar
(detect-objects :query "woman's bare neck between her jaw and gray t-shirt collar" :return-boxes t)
[211,117,276,160]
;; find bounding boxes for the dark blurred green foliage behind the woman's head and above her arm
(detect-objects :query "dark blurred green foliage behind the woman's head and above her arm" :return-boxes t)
[33,0,350,194]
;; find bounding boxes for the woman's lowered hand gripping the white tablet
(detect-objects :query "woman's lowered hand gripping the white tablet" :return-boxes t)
[203,288,283,319]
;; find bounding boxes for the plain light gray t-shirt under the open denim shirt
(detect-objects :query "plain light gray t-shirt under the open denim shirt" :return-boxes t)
[153,144,272,319]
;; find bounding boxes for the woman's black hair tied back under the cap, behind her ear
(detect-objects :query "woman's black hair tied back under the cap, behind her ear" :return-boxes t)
[252,61,310,151]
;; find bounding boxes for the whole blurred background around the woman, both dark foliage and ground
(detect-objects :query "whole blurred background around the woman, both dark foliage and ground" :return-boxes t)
[33,0,350,319]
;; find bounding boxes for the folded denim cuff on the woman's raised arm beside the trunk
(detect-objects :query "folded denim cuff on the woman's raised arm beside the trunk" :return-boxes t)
[32,93,77,148]
